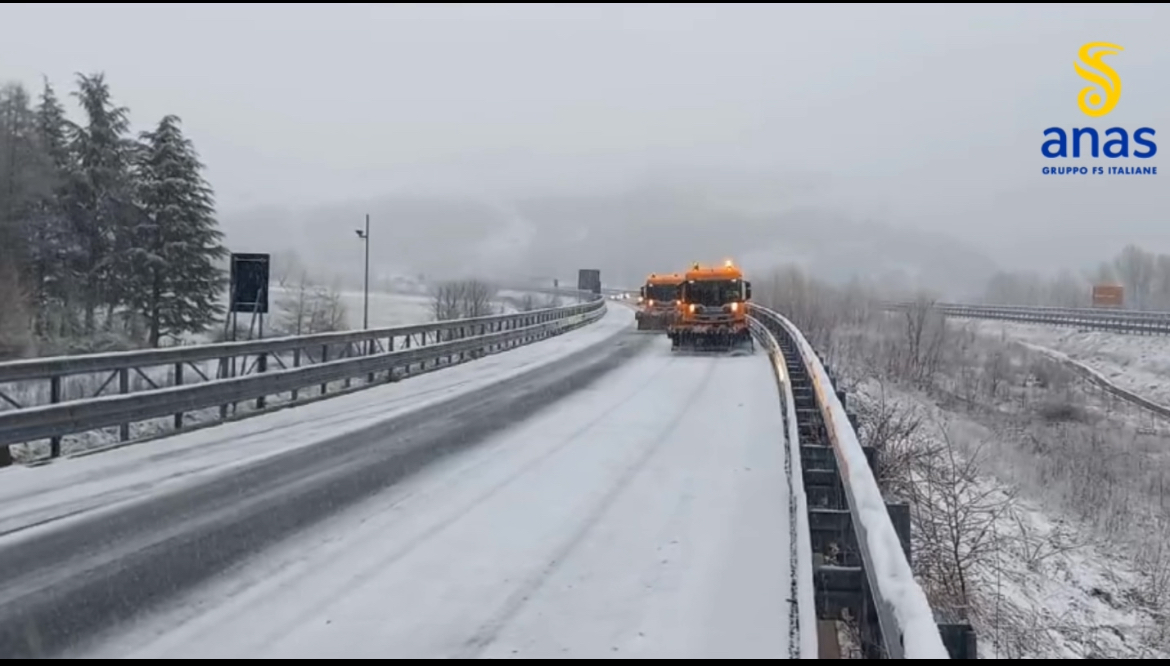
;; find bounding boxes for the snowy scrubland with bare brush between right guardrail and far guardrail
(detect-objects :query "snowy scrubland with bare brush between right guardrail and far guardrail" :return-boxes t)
[841,320,1170,659]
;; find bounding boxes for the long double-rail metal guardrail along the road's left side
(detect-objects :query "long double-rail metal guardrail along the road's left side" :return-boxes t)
[0,293,606,456]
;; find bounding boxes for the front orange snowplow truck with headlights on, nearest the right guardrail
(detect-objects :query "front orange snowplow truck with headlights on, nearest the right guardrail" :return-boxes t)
[667,260,756,353]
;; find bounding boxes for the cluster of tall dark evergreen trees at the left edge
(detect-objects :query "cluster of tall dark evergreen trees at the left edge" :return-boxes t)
[0,74,227,357]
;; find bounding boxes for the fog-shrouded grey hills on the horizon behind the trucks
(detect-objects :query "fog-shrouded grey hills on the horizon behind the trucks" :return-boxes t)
[223,174,996,294]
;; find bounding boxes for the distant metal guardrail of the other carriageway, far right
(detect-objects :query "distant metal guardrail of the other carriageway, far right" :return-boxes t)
[882,302,1170,335]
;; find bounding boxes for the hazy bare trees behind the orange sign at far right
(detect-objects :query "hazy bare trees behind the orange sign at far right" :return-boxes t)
[984,245,1170,310]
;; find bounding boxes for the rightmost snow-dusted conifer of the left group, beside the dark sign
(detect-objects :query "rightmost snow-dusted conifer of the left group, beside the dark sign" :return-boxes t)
[131,116,227,346]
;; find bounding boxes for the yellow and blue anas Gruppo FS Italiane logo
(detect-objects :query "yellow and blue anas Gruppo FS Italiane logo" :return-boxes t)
[1040,42,1158,176]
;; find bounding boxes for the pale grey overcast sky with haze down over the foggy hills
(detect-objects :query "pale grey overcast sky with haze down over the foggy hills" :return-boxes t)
[0,4,1170,292]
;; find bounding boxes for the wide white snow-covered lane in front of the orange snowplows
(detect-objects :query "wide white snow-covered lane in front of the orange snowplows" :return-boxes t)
[80,339,790,659]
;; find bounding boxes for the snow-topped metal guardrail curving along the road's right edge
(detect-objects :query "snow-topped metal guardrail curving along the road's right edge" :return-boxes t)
[749,304,951,659]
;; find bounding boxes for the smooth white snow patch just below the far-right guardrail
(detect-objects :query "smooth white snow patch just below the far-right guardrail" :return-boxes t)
[962,321,1170,406]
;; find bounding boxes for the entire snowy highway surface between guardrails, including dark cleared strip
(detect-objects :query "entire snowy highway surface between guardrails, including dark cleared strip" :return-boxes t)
[0,308,790,659]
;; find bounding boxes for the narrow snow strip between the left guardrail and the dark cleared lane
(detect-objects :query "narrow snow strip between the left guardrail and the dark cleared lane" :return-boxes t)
[0,308,633,536]
